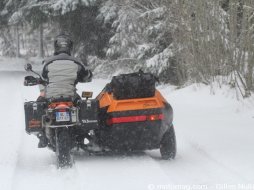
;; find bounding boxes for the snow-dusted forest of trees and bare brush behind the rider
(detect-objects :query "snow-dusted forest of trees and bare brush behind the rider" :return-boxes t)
[0,0,254,97]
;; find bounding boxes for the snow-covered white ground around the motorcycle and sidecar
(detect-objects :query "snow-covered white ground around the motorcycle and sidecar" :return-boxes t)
[0,61,254,190]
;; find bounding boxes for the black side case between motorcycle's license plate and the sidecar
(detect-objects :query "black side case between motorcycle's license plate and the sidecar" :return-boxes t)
[79,99,99,130]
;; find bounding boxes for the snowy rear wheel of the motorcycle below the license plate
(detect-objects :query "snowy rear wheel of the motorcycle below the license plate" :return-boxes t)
[56,128,72,168]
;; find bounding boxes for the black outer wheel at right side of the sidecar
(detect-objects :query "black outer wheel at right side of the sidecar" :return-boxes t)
[160,126,176,160]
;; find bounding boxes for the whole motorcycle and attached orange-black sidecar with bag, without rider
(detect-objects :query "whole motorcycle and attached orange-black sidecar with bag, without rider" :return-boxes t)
[24,64,176,167]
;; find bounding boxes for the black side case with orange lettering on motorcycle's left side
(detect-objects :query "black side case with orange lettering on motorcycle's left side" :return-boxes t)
[24,102,46,134]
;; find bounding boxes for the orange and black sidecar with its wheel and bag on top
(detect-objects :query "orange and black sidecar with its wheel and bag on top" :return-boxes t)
[96,73,176,159]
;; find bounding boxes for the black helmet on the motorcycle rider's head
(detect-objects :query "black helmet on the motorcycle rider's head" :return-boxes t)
[54,34,73,55]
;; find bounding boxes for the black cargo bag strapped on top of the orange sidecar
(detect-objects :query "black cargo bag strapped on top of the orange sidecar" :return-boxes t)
[111,71,157,100]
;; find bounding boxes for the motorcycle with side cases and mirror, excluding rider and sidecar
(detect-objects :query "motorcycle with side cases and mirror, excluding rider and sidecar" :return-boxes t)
[24,64,99,167]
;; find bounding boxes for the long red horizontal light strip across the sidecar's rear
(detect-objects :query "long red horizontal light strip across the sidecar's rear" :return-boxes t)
[107,114,164,125]
